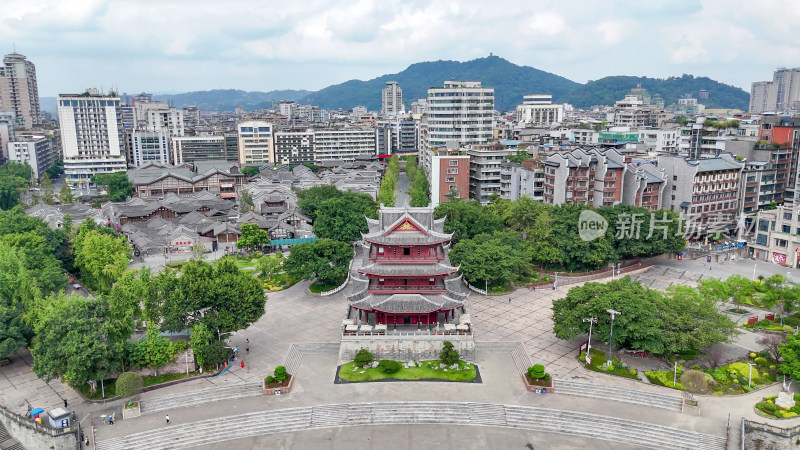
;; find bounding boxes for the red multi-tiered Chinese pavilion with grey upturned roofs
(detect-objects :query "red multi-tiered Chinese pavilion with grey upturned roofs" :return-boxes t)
[347,206,467,325]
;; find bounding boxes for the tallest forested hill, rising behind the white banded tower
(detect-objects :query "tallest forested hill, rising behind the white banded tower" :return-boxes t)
[301,56,581,111]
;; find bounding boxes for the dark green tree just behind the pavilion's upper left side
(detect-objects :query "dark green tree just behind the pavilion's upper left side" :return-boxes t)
[314,192,378,242]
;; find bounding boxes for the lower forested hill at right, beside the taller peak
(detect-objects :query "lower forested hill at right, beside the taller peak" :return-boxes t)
[564,75,750,111]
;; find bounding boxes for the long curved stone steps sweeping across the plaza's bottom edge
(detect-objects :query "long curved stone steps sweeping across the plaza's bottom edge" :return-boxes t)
[97,402,725,450]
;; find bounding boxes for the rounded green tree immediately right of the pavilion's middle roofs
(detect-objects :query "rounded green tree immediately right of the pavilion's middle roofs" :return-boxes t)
[450,231,530,284]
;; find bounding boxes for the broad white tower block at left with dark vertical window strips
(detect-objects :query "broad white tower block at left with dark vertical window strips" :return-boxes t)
[58,89,126,185]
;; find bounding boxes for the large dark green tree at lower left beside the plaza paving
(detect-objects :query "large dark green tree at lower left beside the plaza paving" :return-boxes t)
[31,294,122,386]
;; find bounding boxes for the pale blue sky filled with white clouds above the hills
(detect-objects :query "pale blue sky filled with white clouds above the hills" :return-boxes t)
[0,0,800,96]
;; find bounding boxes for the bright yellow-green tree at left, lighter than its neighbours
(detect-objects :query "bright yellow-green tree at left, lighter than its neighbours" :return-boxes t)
[75,230,131,292]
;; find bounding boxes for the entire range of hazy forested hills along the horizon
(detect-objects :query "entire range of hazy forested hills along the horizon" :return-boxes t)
[41,56,750,112]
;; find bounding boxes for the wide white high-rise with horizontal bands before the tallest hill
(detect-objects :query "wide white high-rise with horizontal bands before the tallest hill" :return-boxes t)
[423,81,494,149]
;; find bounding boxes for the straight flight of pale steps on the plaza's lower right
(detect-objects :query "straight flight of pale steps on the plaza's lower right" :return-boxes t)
[554,379,683,412]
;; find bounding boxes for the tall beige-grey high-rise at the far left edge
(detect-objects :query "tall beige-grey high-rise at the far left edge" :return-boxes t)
[0,53,42,128]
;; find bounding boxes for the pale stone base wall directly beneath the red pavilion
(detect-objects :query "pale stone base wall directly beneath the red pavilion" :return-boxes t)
[339,335,475,364]
